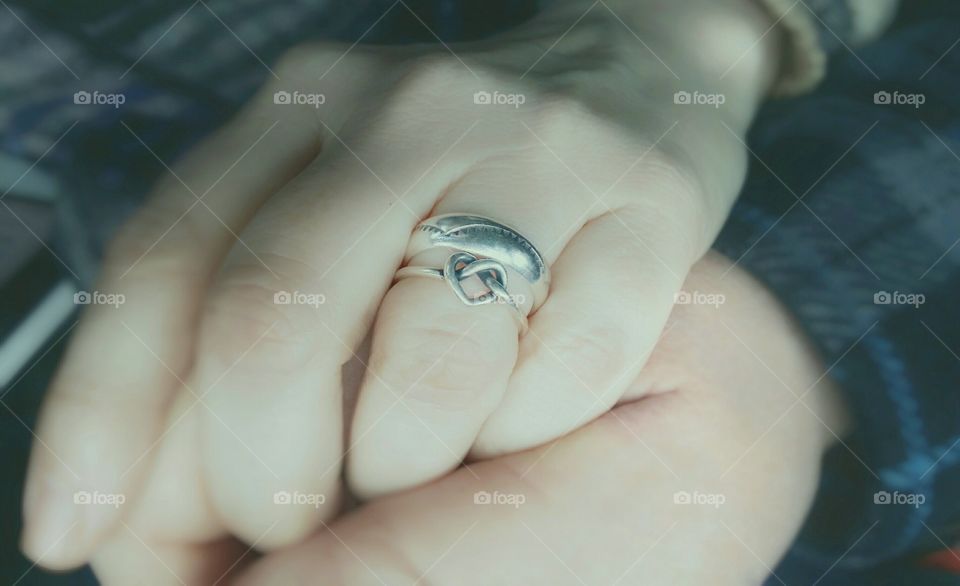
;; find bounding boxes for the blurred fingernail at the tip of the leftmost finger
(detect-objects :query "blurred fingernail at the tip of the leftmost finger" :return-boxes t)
[20,479,80,565]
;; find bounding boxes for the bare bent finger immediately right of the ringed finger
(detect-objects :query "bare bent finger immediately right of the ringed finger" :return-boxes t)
[472,209,689,458]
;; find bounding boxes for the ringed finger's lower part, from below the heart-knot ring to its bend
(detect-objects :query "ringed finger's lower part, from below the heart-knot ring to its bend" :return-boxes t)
[348,279,517,498]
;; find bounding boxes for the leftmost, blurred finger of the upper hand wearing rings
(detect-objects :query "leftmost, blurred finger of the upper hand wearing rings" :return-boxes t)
[23,83,316,568]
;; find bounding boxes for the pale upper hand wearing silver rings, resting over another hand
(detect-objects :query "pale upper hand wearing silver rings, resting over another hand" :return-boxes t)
[24,0,776,567]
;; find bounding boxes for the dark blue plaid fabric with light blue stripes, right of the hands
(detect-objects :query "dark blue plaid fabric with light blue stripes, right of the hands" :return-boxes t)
[717,1,960,586]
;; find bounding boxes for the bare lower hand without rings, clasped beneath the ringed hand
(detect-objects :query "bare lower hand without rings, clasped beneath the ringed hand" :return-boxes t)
[95,255,845,586]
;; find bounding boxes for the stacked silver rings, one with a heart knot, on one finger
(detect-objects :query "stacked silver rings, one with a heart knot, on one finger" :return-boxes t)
[396,214,550,331]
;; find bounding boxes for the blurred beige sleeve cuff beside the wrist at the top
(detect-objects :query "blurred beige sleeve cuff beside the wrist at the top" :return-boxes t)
[758,0,899,95]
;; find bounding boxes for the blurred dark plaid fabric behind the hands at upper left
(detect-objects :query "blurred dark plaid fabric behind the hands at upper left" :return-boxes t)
[0,0,534,279]
